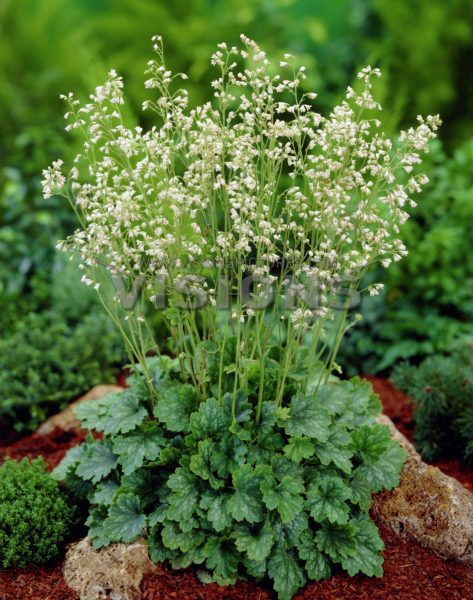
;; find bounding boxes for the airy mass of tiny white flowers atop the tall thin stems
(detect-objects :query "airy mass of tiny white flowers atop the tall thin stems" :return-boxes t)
[44,36,440,325]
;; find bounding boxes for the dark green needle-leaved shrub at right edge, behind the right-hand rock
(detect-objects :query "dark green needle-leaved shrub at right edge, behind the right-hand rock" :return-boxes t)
[391,346,473,463]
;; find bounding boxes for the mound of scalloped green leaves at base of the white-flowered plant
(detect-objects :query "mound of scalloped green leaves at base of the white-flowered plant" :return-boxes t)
[55,355,404,600]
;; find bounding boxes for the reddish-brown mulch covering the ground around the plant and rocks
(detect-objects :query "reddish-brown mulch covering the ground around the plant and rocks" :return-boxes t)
[0,377,473,600]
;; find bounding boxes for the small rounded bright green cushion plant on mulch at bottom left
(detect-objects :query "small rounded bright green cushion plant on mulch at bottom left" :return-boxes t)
[0,458,77,569]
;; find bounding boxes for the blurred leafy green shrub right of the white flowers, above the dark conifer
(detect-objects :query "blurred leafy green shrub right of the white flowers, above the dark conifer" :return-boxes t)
[339,140,473,375]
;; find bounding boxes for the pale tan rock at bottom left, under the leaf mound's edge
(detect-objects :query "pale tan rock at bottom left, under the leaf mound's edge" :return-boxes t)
[63,537,156,600]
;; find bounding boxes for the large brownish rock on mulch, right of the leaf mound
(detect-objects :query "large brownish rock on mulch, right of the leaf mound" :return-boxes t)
[373,415,473,566]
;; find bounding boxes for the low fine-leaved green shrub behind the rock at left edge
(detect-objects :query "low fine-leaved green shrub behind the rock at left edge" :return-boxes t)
[0,311,125,431]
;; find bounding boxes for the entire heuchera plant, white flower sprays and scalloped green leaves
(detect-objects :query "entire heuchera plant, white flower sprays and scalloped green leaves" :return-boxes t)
[48,36,440,599]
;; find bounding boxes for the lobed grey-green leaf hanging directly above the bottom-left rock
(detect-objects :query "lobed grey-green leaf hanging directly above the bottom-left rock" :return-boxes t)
[104,494,146,544]
